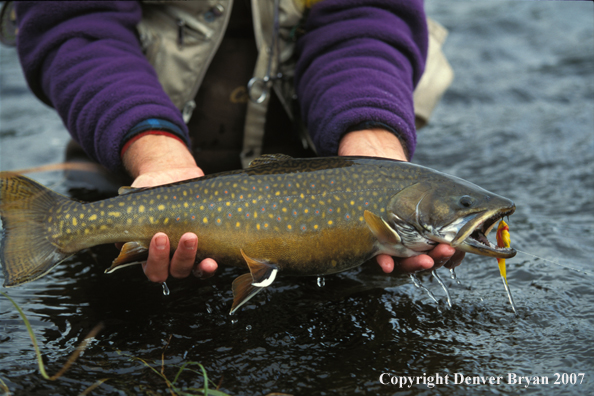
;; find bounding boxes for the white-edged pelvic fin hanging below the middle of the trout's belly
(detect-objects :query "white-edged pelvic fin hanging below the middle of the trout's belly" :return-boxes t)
[229,249,278,314]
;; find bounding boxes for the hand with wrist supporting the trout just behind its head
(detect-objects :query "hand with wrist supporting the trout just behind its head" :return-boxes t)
[338,128,464,273]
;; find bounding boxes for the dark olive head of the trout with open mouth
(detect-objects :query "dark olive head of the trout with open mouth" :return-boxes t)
[387,174,516,258]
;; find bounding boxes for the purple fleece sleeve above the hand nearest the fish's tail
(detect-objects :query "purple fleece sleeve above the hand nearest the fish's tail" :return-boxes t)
[15,1,188,170]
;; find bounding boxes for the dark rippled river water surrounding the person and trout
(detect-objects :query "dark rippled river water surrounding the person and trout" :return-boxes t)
[0,1,594,395]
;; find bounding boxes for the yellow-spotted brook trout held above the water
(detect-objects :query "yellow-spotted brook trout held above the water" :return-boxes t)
[0,155,516,312]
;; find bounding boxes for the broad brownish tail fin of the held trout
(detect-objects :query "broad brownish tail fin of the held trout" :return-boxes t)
[0,172,72,287]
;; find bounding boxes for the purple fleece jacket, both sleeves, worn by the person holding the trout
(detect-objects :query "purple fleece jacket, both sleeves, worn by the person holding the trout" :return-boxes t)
[15,0,428,170]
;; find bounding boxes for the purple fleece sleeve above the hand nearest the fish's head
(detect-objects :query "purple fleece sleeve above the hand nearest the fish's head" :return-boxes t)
[295,0,428,158]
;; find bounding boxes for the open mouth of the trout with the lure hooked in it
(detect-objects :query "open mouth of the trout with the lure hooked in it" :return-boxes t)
[450,205,517,258]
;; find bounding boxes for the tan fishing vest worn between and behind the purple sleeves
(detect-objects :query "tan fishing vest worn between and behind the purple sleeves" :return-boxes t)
[137,0,453,167]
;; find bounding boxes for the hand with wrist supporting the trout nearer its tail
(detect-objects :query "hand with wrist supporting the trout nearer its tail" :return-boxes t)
[122,135,217,282]
